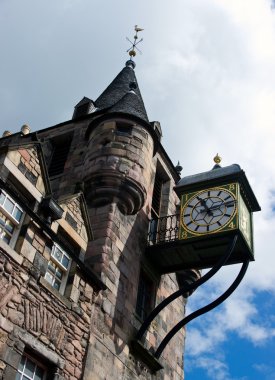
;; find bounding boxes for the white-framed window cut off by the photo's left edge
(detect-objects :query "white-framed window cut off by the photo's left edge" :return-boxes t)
[0,190,23,245]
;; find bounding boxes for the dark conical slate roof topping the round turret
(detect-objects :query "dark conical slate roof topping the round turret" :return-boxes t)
[95,60,149,123]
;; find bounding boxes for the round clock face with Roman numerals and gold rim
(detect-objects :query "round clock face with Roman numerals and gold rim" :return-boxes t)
[181,184,237,235]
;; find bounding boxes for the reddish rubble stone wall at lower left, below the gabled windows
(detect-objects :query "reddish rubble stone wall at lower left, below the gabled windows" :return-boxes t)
[0,243,93,380]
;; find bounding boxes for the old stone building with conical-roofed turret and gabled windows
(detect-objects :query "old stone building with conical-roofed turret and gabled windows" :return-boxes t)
[0,60,198,380]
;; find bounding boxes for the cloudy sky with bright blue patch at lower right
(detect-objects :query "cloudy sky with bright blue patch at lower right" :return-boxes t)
[0,0,275,380]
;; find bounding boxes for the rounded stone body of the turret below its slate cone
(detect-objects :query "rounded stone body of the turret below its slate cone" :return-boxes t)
[83,119,153,214]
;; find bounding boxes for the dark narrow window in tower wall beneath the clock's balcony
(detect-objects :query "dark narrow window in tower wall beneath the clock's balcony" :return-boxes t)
[136,270,156,321]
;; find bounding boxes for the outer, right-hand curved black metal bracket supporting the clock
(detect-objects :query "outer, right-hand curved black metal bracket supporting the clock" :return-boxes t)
[154,259,249,359]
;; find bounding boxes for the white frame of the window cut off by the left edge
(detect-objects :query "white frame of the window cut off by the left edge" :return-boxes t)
[0,188,25,249]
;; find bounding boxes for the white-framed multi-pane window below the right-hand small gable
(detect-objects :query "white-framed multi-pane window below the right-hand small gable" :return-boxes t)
[45,244,71,294]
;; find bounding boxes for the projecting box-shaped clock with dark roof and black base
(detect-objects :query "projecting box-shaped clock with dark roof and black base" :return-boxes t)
[147,161,261,273]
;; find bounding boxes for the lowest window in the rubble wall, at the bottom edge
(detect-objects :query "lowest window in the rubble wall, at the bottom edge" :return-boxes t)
[15,355,46,380]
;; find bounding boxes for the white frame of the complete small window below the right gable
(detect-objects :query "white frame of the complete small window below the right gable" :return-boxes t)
[44,243,72,295]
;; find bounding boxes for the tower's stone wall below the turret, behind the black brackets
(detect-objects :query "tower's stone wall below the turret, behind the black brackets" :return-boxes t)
[84,204,185,380]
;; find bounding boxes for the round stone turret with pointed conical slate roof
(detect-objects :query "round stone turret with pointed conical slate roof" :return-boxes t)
[83,60,157,214]
